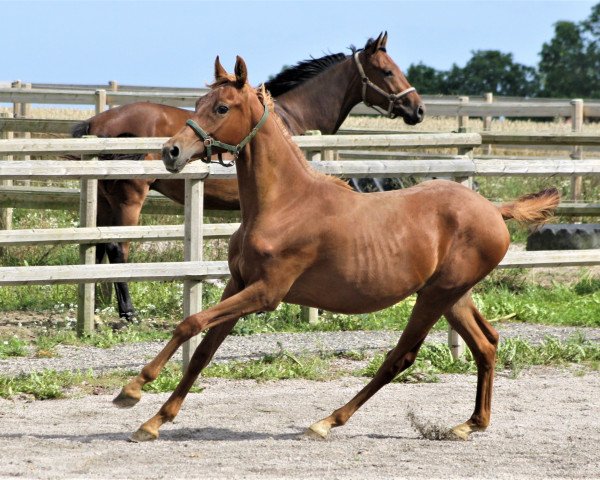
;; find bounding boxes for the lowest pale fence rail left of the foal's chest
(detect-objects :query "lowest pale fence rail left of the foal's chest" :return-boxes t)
[0,262,229,286]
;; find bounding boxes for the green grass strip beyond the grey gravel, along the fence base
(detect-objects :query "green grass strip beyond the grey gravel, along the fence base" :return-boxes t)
[0,269,600,357]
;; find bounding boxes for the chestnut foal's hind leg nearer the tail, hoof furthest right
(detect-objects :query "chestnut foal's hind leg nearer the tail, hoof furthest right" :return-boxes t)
[444,294,498,440]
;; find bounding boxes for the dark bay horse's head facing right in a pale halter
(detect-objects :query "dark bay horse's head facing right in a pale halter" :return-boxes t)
[353,32,425,125]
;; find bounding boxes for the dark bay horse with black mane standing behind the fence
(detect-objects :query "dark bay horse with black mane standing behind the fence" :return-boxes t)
[72,32,424,320]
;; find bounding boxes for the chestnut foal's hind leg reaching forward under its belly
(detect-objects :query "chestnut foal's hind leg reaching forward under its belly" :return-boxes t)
[306,288,457,438]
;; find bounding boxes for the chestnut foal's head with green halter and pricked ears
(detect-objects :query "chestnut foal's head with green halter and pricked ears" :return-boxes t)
[162,56,269,172]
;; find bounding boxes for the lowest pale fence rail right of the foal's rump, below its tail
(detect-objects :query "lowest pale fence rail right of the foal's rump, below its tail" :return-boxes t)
[499,249,600,268]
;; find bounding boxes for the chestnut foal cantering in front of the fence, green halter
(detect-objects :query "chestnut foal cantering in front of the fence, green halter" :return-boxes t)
[114,57,559,441]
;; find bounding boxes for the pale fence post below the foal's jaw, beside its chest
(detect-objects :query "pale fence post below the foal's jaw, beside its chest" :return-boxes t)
[183,178,204,370]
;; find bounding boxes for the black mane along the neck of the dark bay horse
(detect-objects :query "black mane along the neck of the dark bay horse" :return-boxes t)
[265,38,385,97]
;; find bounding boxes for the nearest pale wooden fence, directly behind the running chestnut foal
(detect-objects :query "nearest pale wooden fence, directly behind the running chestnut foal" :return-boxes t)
[0,134,600,359]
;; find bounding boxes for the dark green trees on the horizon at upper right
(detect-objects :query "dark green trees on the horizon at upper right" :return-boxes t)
[407,3,600,98]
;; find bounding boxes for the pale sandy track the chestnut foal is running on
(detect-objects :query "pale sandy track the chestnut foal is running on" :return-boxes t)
[0,369,600,479]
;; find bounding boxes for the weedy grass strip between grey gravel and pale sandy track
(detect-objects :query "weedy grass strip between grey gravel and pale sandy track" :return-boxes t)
[0,337,600,400]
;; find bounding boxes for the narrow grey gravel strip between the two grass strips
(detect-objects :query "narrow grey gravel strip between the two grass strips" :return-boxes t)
[0,323,600,375]
